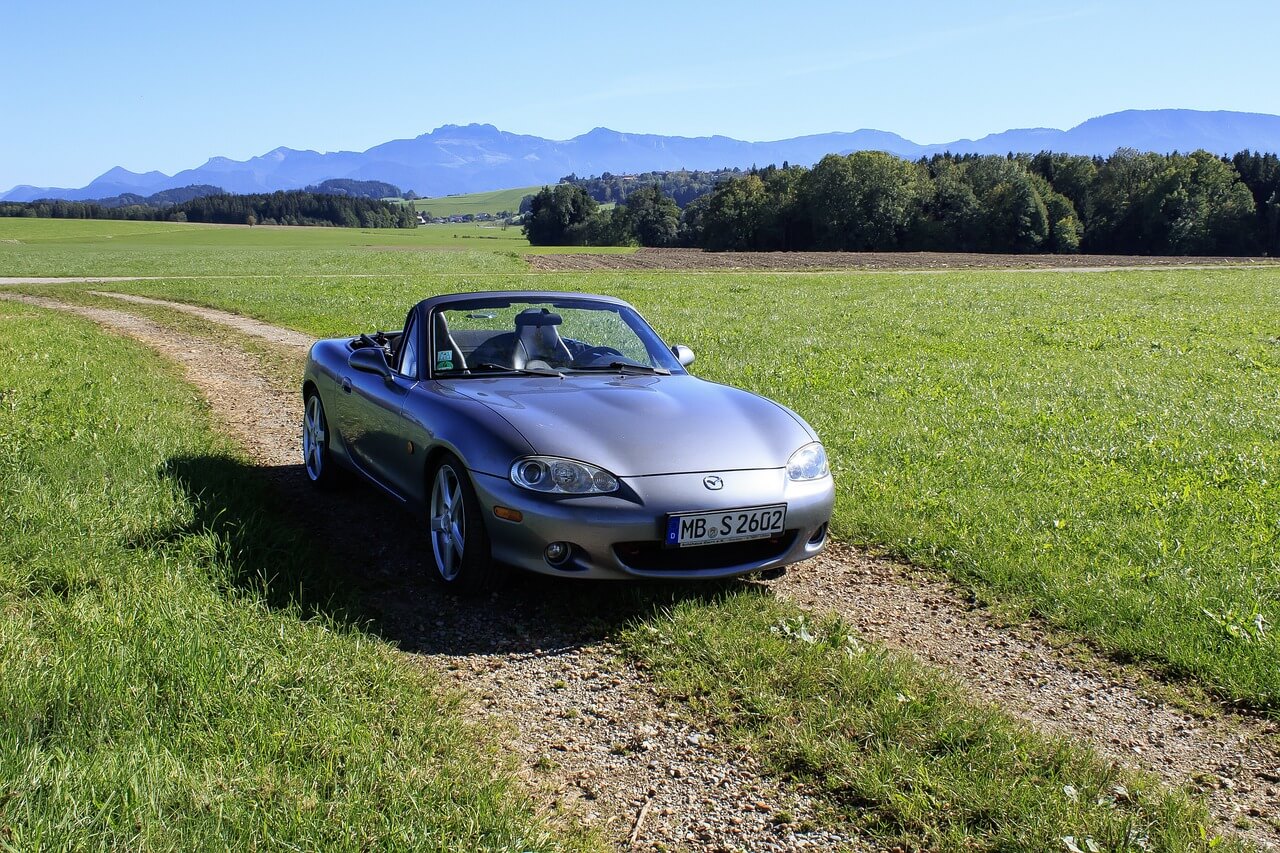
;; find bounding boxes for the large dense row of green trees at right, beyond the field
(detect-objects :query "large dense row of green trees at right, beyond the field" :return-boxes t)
[525,149,1280,256]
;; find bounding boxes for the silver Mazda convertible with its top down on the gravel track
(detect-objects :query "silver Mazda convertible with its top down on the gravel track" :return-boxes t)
[302,291,835,588]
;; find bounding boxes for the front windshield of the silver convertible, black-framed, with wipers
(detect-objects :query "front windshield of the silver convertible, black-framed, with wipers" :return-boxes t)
[431,297,684,377]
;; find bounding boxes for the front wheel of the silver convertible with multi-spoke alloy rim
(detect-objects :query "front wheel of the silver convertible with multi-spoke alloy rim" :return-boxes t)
[426,453,499,592]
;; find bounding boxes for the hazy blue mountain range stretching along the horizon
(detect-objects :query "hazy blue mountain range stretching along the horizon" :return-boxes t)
[10,110,1280,201]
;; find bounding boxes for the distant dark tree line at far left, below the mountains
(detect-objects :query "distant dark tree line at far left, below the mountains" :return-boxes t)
[0,190,417,228]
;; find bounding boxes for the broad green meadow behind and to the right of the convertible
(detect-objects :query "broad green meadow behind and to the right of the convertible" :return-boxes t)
[0,217,1280,711]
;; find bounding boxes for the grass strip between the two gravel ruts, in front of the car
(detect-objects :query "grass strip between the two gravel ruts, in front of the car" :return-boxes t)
[622,592,1245,852]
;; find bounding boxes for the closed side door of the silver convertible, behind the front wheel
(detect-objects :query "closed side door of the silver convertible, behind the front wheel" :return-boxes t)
[343,311,422,501]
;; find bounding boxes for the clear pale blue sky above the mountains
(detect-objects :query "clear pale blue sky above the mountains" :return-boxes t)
[0,0,1280,190]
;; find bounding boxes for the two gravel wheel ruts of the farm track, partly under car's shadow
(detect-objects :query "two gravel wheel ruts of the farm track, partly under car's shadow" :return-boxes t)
[0,293,1280,850]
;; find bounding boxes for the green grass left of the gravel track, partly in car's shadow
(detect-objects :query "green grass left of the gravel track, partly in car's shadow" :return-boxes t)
[0,297,590,850]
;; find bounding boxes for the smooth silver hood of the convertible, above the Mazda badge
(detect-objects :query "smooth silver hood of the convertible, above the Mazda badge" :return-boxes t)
[453,374,814,476]
